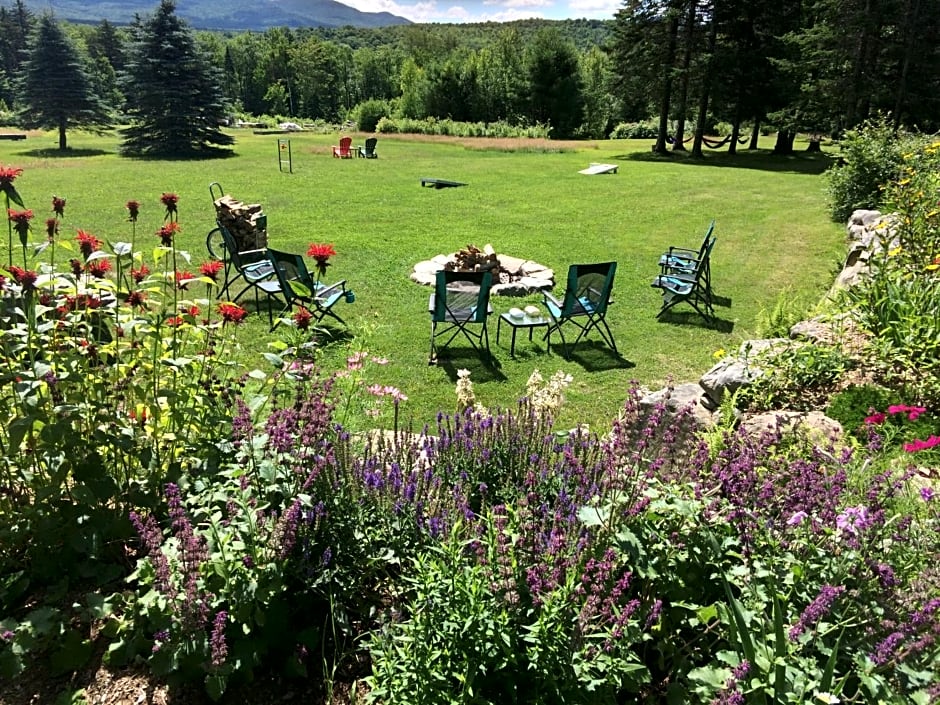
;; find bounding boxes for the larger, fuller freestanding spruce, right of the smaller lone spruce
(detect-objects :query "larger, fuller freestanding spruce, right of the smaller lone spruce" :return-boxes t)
[121,0,234,156]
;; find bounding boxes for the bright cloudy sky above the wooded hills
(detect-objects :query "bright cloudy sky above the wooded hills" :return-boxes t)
[339,0,623,22]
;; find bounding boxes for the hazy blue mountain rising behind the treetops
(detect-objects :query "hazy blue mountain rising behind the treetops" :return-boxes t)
[14,0,410,31]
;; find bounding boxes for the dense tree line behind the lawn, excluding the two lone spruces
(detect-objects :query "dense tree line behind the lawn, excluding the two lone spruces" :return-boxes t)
[0,0,940,151]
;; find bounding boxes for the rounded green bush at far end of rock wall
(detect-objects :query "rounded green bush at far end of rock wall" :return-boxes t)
[827,118,912,223]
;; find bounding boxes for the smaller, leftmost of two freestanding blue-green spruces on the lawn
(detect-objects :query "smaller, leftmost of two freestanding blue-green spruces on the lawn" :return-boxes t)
[18,14,111,150]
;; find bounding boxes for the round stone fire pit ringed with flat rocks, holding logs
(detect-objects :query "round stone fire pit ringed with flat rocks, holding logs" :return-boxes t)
[411,245,555,296]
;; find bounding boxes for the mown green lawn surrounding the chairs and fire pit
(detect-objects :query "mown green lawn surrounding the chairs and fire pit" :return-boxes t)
[0,132,844,429]
